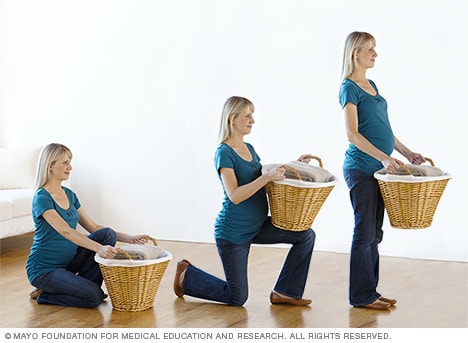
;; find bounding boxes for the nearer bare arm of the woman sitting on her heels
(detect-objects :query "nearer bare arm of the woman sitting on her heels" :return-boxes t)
[42,210,117,258]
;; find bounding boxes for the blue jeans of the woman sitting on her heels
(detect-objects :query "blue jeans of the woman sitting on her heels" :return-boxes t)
[33,228,117,308]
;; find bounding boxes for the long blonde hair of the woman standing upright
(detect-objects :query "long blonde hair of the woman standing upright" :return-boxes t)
[341,31,376,81]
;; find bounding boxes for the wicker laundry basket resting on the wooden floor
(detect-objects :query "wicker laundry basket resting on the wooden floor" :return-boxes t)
[95,239,172,311]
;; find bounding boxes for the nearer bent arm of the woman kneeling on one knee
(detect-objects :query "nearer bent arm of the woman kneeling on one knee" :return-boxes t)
[219,166,285,205]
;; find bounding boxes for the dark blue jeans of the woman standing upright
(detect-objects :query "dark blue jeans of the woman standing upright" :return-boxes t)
[343,169,385,306]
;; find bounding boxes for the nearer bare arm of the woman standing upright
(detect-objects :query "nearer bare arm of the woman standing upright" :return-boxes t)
[343,102,402,172]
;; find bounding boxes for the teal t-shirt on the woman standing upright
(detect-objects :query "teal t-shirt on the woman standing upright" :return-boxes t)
[339,79,395,175]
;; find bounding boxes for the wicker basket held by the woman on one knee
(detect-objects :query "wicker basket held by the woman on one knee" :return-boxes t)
[265,156,336,231]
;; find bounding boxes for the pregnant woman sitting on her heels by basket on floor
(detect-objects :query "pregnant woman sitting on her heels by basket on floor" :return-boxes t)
[26,143,148,308]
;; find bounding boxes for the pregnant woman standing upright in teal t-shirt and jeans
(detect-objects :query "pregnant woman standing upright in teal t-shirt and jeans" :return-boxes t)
[339,32,425,310]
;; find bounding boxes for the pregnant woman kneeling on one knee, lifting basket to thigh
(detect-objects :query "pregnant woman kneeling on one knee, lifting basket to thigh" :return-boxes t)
[174,96,315,306]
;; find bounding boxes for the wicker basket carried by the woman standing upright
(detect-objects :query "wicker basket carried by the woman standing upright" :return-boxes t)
[374,157,451,229]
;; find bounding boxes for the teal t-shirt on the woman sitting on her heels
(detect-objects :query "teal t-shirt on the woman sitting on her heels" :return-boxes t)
[26,187,81,283]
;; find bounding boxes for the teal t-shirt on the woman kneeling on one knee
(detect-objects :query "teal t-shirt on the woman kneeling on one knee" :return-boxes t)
[214,143,268,244]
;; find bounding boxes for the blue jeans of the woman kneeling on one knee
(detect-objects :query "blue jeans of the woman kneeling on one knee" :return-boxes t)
[182,217,315,306]
